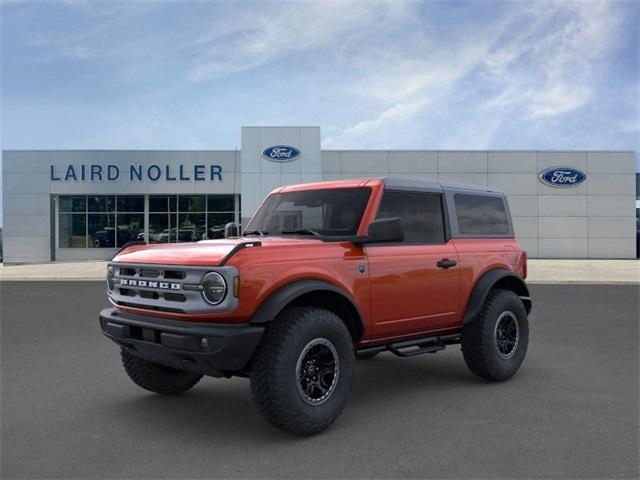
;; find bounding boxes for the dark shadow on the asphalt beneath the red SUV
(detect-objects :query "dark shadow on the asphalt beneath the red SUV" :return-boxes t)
[103,354,486,442]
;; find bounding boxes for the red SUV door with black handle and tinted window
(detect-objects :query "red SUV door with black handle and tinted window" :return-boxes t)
[366,191,460,339]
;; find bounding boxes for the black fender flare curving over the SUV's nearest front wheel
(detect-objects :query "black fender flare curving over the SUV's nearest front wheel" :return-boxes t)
[250,280,364,337]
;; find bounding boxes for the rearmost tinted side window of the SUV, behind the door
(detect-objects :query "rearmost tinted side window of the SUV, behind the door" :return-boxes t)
[454,193,511,235]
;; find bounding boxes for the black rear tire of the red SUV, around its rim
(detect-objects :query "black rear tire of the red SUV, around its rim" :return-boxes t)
[462,289,529,381]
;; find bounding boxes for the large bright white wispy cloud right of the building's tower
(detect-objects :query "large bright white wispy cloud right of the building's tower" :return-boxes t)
[325,1,625,148]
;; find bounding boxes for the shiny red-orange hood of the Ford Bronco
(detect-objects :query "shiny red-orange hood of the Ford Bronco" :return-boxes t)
[113,237,321,267]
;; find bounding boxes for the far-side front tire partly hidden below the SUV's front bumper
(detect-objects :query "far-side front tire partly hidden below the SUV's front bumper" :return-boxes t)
[120,348,202,395]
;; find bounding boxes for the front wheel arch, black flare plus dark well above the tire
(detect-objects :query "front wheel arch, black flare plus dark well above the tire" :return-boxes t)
[250,280,364,342]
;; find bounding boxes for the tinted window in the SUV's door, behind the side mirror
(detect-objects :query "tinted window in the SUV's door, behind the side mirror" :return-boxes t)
[376,190,444,243]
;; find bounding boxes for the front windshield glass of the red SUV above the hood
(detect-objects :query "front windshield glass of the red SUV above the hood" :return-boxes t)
[244,188,371,236]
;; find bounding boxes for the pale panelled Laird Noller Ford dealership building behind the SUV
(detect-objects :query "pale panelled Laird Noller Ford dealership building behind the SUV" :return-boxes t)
[2,126,636,263]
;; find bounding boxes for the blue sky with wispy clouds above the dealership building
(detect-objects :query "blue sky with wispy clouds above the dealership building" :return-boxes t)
[0,0,640,223]
